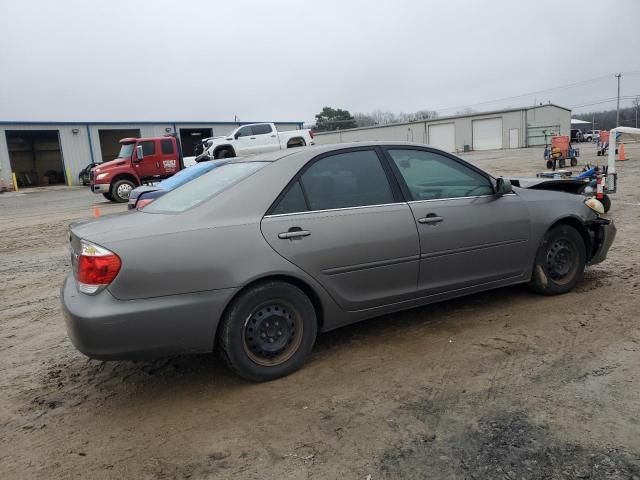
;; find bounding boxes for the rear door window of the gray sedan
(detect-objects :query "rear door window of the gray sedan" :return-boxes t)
[300,150,394,210]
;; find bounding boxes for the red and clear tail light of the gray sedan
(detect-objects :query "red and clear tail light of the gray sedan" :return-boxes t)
[76,240,122,295]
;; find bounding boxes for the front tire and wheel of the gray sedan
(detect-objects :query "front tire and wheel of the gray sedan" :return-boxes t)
[529,224,587,295]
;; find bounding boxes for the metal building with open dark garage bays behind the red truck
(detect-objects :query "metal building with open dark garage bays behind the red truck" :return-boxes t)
[0,122,302,187]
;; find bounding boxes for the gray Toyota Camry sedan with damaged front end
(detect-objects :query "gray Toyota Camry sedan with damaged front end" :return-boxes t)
[62,142,615,381]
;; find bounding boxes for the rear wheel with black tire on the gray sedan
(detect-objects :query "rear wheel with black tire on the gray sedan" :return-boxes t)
[218,281,318,382]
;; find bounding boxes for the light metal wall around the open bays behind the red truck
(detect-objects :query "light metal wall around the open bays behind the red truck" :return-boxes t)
[0,122,302,187]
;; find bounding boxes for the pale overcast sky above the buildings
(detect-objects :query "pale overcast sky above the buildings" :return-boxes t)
[0,0,640,121]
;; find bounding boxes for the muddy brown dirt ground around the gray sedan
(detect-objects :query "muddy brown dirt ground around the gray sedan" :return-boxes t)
[0,144,640,480]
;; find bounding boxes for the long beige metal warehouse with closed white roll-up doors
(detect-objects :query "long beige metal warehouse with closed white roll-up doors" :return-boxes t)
[316,104,571,152]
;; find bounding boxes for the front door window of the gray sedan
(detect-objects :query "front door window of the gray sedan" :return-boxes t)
[389,149,494,200]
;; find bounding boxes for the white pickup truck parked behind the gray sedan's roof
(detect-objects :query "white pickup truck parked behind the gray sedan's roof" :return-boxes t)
[198,123,315,159]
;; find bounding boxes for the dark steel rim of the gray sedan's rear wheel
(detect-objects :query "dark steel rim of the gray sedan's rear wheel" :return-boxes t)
[242,300,303,367]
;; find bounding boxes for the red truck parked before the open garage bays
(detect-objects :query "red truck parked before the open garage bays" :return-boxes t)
[90,135,185,203]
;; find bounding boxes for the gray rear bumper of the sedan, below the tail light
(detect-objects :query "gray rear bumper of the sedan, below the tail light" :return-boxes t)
[61,275,235,360]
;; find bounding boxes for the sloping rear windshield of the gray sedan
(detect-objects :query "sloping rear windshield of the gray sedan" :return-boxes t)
[144,162,268,213]
